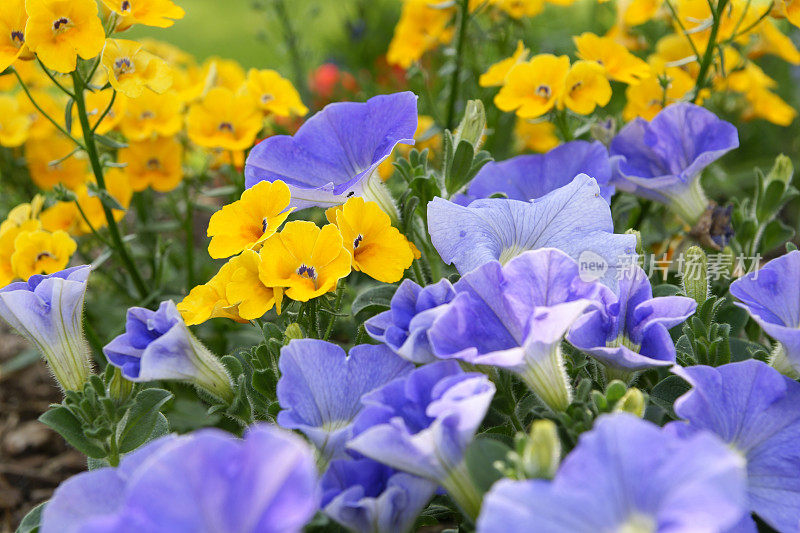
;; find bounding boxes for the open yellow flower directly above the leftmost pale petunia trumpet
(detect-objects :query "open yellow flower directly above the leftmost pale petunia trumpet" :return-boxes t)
[11,230,78,280]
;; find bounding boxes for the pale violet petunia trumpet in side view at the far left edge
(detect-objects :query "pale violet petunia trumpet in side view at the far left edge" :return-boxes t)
[0,265,92,391]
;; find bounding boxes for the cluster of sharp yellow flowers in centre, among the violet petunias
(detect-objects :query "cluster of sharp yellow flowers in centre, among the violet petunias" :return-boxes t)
[178,181,419,325]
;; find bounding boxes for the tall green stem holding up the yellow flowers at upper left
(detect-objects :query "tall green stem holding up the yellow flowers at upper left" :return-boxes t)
[72,71,150,298]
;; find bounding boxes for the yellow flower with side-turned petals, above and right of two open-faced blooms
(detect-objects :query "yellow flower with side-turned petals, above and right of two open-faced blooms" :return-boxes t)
[572,32,650,84]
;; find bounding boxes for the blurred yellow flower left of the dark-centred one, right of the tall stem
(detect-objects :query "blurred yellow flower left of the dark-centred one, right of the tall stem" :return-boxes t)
[119,92,183,141]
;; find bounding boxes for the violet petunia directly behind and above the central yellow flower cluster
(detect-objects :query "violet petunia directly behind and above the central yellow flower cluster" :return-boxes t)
[244,92,417,209]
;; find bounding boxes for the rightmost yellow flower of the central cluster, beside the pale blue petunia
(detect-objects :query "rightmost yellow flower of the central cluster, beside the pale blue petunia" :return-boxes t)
[325,197,414,283]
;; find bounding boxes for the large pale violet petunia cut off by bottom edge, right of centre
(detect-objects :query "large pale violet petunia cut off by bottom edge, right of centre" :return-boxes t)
[478,413,747,533]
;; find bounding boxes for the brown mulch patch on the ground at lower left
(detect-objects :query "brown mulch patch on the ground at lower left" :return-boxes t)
[0,320,86,533]
